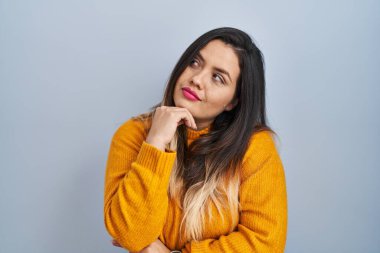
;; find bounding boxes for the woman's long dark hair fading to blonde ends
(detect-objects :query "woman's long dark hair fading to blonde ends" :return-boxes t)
[133,27,274,241]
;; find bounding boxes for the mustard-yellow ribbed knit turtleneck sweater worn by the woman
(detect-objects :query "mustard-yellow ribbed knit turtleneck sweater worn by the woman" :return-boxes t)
[104,119,287,253]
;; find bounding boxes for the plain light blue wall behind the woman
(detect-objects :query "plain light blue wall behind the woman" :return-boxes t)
[0,0,380,253]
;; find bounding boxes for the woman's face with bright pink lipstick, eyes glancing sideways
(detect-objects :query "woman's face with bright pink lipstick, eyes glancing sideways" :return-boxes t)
[174,40,240,129]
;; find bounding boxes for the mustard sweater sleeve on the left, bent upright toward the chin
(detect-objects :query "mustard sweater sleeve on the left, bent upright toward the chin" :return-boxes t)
[104,120,176,251]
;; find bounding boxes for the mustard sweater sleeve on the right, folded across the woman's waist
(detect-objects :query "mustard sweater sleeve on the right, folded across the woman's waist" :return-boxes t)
[182,132,287,253]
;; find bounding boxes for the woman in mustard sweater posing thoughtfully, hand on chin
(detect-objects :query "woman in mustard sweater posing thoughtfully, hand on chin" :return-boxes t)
[104,28,287,253]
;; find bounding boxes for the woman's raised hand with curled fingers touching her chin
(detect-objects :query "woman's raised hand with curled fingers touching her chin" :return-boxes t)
[146,106,197,150]
